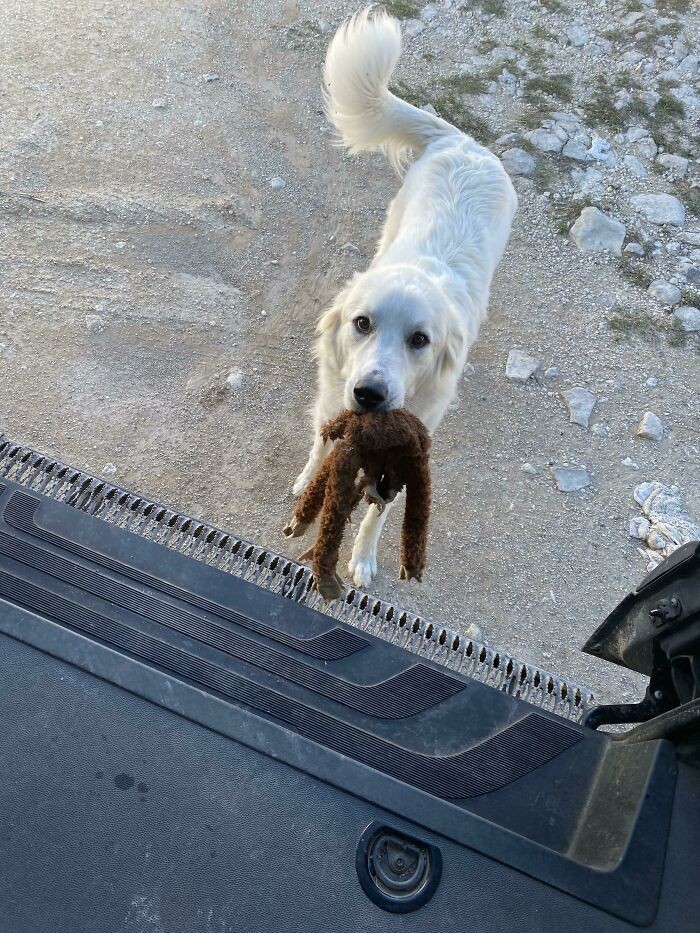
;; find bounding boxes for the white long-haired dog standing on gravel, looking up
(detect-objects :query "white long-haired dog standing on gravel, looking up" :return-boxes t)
[294,7,517,588]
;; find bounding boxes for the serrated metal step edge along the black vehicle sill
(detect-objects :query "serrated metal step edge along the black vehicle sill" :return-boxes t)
[0,435,595,722]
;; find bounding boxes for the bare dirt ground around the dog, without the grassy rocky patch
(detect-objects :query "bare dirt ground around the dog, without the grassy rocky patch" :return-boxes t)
[0,0,700,699]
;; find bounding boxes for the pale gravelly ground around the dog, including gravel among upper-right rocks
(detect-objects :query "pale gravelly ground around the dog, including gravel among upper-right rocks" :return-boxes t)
[0,0,700,700]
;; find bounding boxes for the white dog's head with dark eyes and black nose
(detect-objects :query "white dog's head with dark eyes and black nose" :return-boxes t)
[317,267,466,411]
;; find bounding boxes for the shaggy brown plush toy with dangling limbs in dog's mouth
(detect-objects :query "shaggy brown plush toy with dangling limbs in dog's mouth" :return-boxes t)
[284,408,430,600]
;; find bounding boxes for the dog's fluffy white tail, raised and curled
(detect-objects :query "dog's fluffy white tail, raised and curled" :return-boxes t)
[324,6,460,172]
